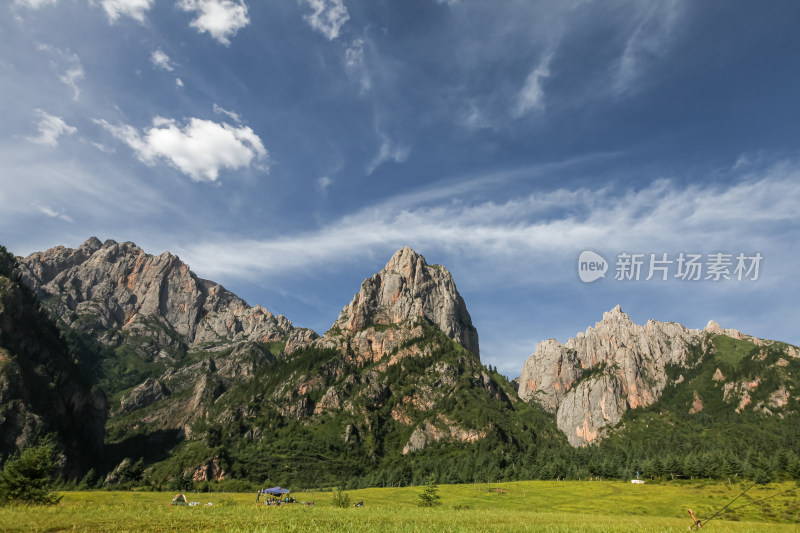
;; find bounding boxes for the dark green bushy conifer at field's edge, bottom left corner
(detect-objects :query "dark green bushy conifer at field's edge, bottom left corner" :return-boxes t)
[0,440,61,505]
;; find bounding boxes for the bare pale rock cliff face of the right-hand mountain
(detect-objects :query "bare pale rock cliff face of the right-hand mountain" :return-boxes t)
[519,306,703,446]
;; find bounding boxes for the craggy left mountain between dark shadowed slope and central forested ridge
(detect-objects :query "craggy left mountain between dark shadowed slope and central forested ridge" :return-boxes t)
[18,237,316,401]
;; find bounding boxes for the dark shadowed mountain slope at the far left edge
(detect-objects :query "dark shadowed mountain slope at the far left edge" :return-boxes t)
[0,246,106,478]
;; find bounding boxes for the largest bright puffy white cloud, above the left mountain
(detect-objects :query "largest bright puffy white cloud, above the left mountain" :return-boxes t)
[95,117,268,181]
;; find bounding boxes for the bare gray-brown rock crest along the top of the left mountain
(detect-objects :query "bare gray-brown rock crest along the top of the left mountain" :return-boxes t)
[18,237,308,345]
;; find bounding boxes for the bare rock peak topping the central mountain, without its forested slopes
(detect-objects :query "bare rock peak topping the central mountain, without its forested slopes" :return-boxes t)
[320,246,480,358]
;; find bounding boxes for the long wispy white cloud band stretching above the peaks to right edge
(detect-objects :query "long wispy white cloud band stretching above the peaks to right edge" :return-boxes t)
[181,167,800,284]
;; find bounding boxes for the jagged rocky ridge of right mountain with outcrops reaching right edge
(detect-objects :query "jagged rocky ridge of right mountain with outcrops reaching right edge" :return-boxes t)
[519,306,800,446]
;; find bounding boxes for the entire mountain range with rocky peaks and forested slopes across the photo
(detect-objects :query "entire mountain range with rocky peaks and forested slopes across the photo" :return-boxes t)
[0,238,800,487]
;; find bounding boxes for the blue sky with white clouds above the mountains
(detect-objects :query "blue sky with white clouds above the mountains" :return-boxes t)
[0,0,800,377]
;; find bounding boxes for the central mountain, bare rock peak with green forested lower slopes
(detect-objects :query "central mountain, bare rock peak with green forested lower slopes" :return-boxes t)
[147,248,563,485]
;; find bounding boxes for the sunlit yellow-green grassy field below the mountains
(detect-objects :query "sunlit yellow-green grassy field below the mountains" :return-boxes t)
[0,481,800,531]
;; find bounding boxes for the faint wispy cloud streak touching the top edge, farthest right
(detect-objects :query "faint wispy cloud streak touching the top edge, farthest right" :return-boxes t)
[611,0,680,95]
